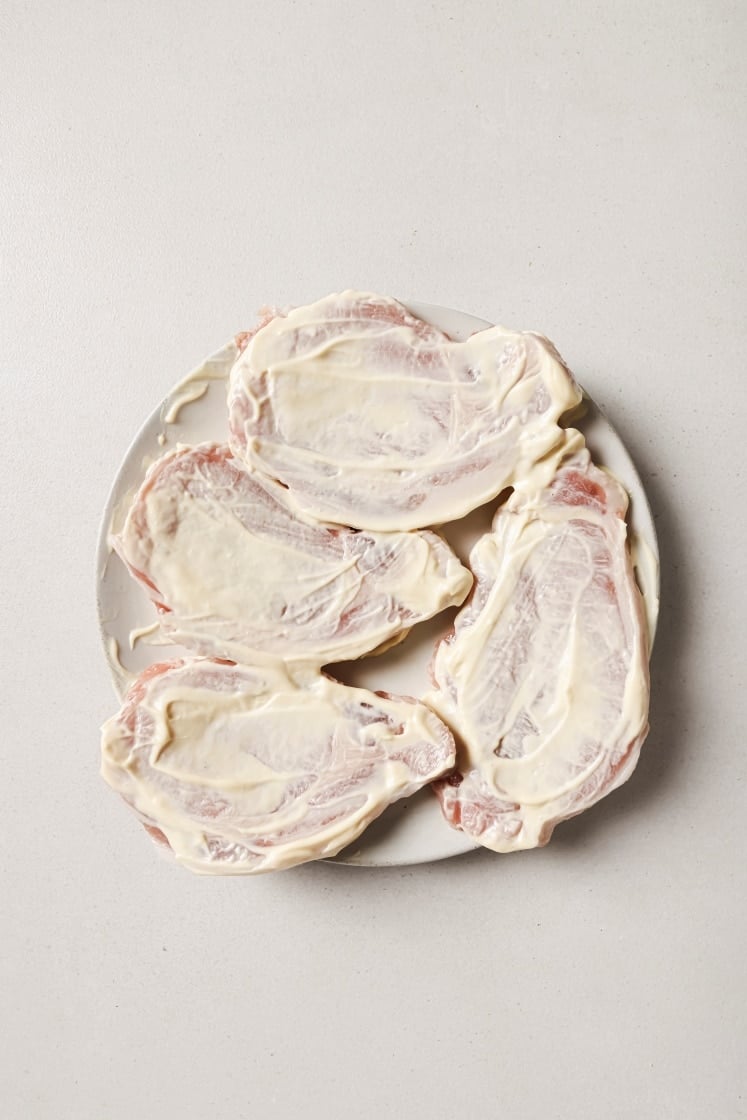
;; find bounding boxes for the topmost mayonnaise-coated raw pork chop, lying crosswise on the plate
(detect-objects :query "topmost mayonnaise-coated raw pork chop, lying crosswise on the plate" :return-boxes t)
[228,291,581,530]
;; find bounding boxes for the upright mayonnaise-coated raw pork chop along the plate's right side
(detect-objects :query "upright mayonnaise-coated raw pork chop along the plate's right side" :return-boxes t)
[426,433,648,851]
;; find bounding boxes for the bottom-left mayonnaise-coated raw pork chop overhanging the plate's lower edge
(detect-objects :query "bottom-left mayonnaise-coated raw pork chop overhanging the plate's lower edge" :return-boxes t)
[102,659,455,875]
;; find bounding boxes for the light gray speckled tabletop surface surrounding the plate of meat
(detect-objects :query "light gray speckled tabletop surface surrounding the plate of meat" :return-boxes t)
[0,0,747,1120]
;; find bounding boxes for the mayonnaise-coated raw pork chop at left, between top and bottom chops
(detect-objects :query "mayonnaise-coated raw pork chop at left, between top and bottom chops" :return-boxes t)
[112,444,471,665]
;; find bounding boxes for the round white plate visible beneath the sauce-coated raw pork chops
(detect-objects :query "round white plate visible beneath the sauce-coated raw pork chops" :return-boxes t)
[96,302,659,867]
